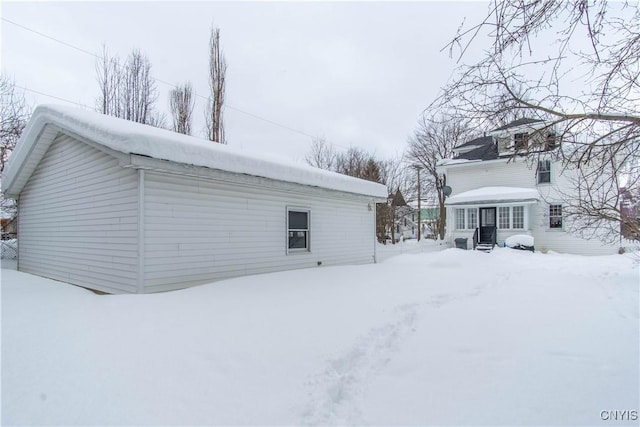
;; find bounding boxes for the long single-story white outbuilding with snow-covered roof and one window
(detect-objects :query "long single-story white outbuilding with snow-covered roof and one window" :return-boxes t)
[2,106,387,293]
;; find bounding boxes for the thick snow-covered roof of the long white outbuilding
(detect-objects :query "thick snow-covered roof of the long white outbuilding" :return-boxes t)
[2,105,387,199]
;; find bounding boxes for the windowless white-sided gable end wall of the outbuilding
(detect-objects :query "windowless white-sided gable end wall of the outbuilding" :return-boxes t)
[18,135,138,293]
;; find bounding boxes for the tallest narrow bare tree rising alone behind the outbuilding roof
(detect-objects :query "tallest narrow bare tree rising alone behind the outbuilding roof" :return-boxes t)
[205,27,227,144]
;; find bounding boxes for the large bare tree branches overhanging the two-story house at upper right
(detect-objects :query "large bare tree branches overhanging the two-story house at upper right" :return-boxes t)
[440,0,640,242]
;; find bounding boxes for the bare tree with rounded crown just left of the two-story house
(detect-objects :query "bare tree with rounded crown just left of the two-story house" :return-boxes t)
[408,113,471,239]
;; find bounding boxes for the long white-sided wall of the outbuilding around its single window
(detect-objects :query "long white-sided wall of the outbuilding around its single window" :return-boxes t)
[144,171,375,292]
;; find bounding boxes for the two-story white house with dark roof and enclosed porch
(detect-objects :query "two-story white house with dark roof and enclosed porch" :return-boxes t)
[439,119,618,255]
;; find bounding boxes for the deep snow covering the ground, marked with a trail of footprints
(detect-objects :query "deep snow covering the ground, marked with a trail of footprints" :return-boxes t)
[1,248,640,426]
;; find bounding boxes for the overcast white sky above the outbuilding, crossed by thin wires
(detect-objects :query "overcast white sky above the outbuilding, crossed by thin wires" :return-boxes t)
[0,1,487,165]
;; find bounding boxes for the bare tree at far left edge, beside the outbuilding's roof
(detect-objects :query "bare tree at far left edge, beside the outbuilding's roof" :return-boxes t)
[0,74,31,173]
